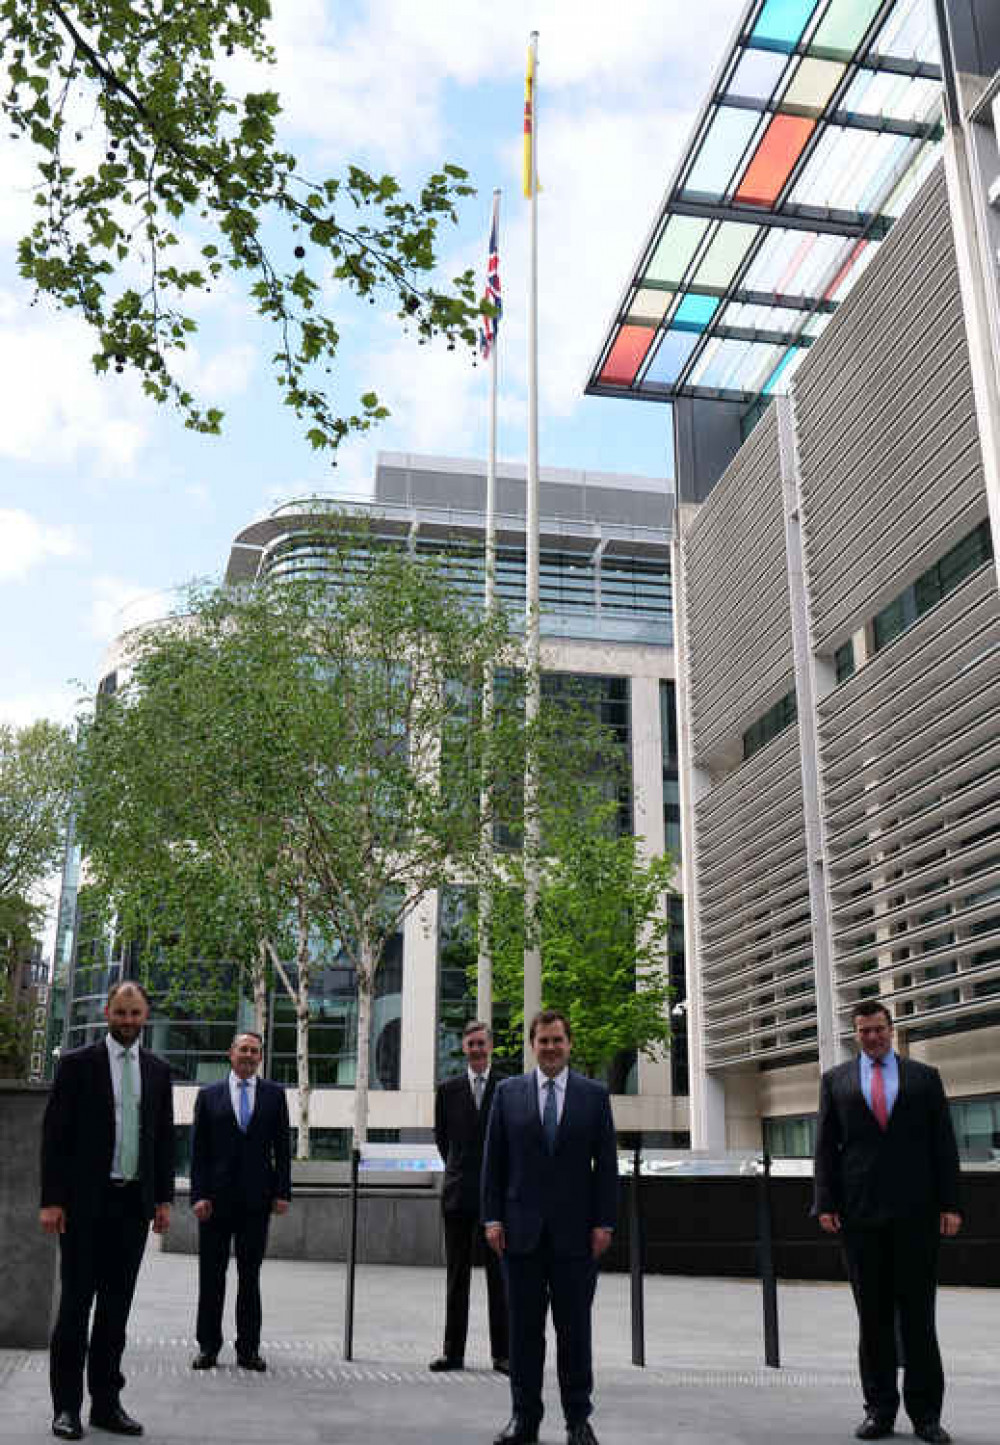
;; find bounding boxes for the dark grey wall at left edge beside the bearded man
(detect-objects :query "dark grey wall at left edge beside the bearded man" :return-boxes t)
[0,1079,58,1350]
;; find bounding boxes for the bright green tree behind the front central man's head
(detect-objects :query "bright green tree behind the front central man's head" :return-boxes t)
[491,782,673,1082]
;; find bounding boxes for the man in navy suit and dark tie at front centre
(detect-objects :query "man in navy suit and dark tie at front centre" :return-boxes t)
[483,1009,618,1445]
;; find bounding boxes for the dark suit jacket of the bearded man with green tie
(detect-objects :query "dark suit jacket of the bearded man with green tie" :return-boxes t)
[42,1039,173,1222]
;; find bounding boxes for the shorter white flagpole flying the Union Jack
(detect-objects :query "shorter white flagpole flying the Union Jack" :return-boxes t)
[475,189,500,1029]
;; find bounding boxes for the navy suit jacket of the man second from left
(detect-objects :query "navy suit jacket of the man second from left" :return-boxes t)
[191,1077,292,1209]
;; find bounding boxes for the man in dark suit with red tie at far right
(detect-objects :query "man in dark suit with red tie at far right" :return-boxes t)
[814,1000,961,1445]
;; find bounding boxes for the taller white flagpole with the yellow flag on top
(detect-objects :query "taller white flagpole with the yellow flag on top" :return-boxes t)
[523,30,542,1069]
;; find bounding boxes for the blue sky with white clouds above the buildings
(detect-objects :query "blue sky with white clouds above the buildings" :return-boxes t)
[0,0,744,745]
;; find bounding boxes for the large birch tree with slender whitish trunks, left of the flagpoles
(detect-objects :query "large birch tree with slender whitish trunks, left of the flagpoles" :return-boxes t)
[79,517,520,1143]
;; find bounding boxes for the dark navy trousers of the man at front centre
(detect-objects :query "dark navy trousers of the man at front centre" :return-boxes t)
[503,1231,597,1429]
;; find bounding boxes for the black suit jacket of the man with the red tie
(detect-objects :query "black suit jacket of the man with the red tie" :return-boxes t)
[814,1059,960,1227]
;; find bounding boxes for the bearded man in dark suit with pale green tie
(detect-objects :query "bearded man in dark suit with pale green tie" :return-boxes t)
[39,981,173,1441]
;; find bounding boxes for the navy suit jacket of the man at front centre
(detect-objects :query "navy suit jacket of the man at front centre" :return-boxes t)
[481,1069,618,1257]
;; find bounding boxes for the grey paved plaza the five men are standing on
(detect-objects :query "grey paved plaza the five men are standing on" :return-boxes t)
[0,1248,1000,1445]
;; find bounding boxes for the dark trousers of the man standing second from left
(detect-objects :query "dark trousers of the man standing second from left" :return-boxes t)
[195,1204,270,1358]
